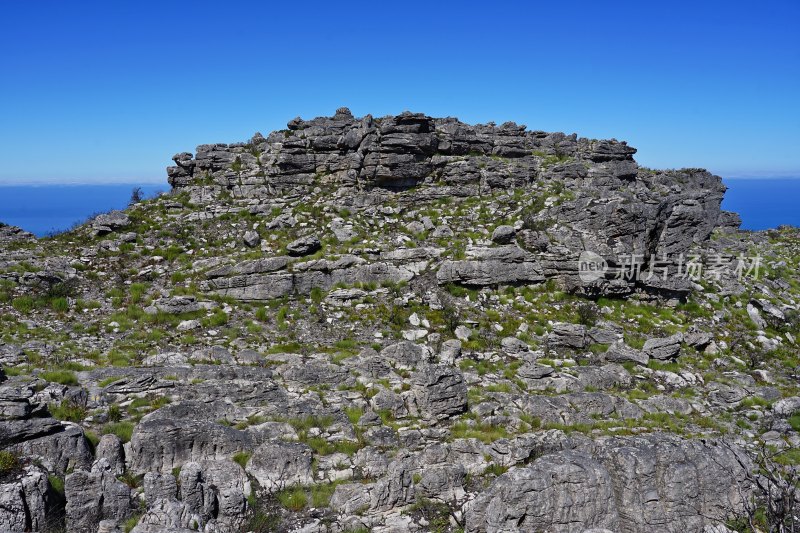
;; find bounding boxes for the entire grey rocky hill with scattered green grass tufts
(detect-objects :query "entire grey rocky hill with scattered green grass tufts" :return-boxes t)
[0,108,800,533]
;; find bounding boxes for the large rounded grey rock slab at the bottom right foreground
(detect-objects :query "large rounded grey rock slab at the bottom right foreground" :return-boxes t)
[467,435,750,533]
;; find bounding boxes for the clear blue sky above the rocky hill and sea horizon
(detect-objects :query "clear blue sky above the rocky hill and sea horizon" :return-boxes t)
[0,0,800,183]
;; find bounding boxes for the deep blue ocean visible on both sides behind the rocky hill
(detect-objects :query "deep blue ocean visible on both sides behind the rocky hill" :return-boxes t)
[0,178,800,237]
